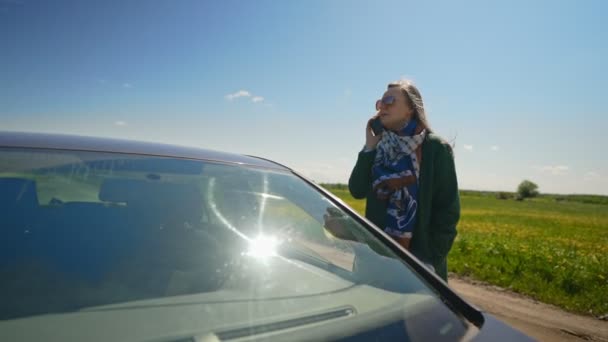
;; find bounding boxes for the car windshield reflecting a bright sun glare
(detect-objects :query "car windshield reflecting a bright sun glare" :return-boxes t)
[0,148,464,339]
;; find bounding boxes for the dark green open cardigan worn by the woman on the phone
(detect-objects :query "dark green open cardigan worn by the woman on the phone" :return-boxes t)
[348,133,460,281]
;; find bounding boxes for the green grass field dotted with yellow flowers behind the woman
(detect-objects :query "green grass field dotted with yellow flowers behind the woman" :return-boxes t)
[328,186,608,316]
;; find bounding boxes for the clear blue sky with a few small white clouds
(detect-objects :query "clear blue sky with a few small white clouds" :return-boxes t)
[0,0,608,194]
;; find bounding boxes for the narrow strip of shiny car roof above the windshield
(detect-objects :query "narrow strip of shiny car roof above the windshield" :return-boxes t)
[0,132,290,171]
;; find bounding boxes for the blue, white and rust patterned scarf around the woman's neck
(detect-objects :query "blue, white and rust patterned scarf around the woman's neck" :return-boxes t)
[372,120,426,238]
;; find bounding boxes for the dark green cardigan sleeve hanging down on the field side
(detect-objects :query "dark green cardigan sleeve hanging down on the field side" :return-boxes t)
[430,144,460,260]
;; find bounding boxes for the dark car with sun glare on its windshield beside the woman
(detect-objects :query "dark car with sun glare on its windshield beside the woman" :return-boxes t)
[0,132,529,342]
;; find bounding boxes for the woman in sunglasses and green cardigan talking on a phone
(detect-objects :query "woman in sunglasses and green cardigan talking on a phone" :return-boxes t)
[348,81,460,280]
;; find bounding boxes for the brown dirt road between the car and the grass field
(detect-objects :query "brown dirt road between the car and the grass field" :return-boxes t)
[449,277,608,342]
